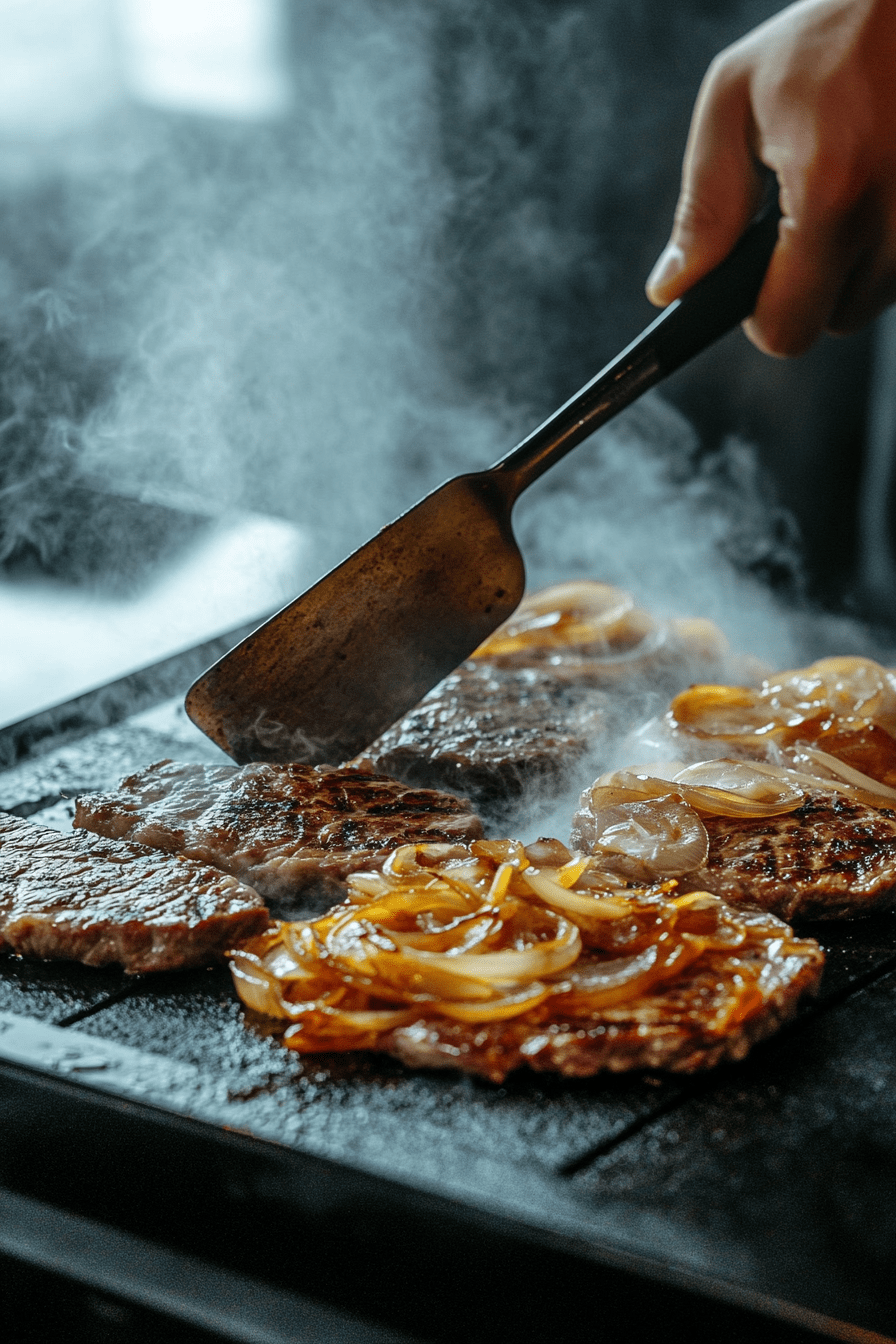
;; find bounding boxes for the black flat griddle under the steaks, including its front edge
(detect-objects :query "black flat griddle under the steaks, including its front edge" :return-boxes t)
[0,650,896,1344]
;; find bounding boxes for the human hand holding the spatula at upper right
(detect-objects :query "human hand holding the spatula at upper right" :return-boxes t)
[647,0,896,355]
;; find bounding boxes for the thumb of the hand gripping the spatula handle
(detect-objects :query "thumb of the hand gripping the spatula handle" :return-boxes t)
[646,62,762,308]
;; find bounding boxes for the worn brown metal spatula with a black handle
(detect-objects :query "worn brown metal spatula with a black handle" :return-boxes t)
[187,202,780,763]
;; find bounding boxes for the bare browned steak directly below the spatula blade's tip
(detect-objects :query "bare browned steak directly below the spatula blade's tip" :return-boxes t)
[75,761,482,898]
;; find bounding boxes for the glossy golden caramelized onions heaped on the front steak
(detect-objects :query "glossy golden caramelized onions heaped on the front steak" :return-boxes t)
[230,840,817,1051]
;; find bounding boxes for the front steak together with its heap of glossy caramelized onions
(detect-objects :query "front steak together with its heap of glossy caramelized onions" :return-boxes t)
[231,840,823,1082]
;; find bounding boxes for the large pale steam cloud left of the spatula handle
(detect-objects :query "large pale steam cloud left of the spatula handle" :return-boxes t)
[0,3,497,583]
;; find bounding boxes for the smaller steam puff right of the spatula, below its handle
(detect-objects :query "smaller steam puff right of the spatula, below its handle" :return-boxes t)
[510,394,802,667]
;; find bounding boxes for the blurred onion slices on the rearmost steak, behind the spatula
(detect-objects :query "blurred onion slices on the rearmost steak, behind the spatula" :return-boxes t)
[473,579,727,661]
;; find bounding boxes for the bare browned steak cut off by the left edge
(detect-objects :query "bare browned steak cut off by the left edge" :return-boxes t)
[0,813,269,976]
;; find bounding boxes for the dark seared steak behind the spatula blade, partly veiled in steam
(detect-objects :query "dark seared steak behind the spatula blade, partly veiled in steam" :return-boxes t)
[359,660,612,825]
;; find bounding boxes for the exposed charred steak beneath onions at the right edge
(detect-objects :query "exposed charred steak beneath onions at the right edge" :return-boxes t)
[681,790,896,919]
